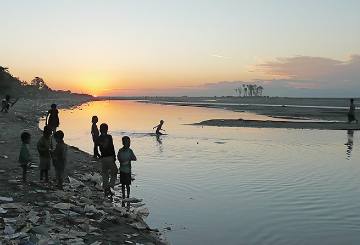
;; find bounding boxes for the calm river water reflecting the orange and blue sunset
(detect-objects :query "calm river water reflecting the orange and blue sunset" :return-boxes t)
[40,101,360,245]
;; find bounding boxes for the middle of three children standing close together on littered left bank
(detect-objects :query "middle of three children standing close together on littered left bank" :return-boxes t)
[37,126,52,182]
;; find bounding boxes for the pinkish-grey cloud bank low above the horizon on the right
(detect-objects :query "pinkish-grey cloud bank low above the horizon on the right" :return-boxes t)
[175,54,360,97]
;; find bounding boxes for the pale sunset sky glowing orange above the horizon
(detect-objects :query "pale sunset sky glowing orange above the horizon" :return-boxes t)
[0,0,360,97]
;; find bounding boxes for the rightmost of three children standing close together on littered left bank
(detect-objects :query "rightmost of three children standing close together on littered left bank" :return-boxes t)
[51,130,67,190]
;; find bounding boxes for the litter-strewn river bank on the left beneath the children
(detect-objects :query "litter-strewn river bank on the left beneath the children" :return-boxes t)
[0,96,169,245]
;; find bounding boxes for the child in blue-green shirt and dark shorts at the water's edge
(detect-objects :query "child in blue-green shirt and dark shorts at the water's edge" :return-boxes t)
[117,136,137,198]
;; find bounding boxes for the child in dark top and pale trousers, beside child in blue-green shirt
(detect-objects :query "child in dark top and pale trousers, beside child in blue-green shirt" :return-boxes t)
[96,123,118,196]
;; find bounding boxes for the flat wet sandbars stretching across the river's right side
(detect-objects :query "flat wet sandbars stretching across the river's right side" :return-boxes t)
[141,97,360,130]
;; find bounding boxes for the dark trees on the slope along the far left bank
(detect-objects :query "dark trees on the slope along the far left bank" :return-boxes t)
[0,66,90,99]
